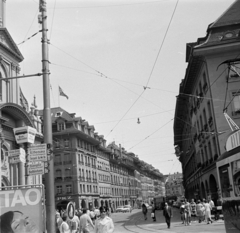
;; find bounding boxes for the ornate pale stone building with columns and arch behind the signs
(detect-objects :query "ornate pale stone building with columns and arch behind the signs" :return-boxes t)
[0,0,43,187]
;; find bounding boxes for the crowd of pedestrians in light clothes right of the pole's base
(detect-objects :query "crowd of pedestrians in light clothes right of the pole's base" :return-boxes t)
[55,206,114,233]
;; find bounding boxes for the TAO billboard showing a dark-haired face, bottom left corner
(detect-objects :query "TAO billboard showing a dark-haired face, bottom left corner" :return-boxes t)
[0,187,44,233]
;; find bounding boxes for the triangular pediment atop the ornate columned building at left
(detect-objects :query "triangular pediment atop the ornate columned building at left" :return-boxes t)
[0,28,24,62]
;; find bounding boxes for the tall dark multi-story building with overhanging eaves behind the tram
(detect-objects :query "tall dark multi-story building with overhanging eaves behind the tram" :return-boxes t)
[174,1,240,201]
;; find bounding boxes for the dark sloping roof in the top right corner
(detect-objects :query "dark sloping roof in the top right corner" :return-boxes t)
[209,0,240,29]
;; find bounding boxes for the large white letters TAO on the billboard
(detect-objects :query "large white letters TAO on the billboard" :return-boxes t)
[0,188,41,207]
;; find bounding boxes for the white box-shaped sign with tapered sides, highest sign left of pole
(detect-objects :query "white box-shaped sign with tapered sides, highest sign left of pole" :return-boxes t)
[13,126,37,144]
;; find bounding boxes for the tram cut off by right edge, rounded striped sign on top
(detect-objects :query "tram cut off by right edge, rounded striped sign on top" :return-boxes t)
[217,130,240,233]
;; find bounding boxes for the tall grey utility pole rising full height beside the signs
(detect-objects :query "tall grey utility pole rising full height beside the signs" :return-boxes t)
[39,0,56,233]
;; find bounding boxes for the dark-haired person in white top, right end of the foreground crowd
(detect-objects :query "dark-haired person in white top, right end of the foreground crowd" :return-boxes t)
[94,206,114,233]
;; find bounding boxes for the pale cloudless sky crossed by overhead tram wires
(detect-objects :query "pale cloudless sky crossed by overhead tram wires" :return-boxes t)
[6,0,234,174]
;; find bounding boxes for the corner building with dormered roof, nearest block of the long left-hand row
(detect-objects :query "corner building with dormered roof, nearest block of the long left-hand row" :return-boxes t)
[47,107,102,211]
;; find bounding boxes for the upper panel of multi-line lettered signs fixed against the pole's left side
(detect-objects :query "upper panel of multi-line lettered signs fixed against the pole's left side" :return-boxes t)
[28,144,47,162]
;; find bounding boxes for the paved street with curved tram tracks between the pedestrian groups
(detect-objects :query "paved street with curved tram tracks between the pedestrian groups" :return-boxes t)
[97,209,226,233]
